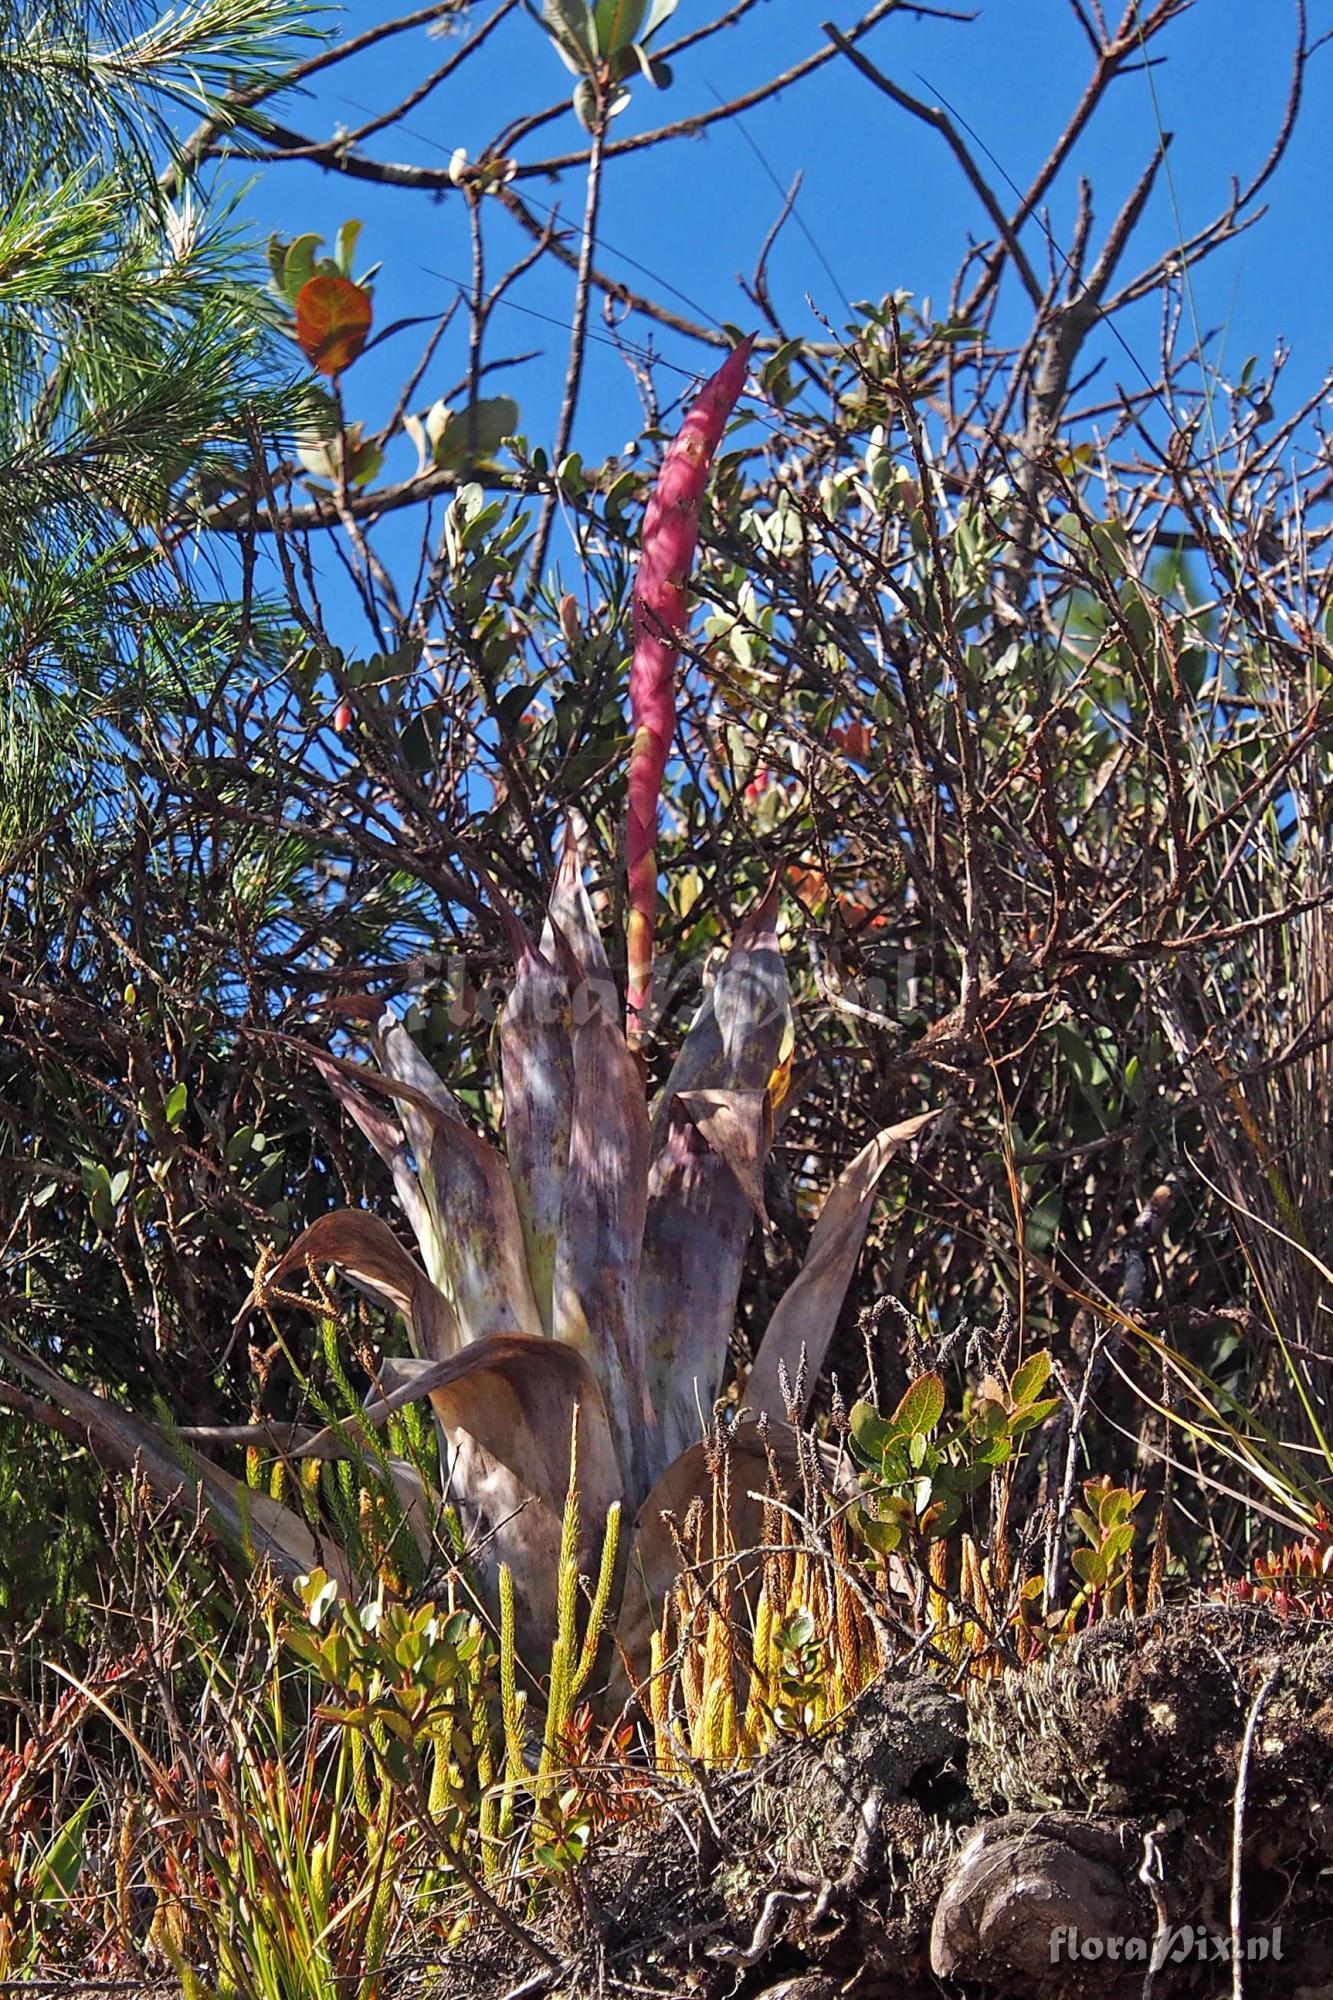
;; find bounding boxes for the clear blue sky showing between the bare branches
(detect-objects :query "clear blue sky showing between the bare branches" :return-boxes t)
[220,0,1333,532]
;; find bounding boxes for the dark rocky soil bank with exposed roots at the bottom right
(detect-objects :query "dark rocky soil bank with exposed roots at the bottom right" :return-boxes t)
[436,1604,1333,2000]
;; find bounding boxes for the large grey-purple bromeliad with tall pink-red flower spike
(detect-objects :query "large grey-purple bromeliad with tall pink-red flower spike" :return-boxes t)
[0,344,927,1656]
